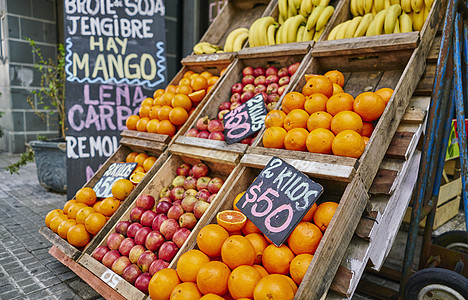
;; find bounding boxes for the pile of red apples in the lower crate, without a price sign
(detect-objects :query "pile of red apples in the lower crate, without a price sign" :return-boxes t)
[92,163,224,294]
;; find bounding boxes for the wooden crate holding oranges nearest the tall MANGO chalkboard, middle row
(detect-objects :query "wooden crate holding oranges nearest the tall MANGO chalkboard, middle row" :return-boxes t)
[121,58,233,149]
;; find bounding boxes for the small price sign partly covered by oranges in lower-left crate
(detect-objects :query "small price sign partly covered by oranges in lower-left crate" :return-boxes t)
[93,163,138,198]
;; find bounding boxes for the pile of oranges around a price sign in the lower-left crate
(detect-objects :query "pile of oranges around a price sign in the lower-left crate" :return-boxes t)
[45,152,156,248]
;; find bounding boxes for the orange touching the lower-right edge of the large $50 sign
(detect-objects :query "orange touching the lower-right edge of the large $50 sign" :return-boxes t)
[288,222,322,255]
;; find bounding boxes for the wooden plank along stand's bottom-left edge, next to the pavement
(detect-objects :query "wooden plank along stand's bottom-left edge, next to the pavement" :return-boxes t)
[49,246,125,300]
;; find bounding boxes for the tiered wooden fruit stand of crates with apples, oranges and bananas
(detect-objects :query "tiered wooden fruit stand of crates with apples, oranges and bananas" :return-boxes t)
[40,0,444,299]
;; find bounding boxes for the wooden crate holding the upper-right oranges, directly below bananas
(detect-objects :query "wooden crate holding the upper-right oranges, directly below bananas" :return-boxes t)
[249,44,425,183]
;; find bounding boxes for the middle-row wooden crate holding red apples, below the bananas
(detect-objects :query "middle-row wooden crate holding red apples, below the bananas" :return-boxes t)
[170,45,310,165]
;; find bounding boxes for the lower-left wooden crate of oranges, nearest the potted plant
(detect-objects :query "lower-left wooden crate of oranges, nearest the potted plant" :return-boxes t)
[39,143,169,260]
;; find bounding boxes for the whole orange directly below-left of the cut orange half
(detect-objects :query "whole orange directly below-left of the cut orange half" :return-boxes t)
[197,224,229,257]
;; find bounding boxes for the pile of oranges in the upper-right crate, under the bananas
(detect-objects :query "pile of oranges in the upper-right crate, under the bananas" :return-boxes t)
[263,70,393,158]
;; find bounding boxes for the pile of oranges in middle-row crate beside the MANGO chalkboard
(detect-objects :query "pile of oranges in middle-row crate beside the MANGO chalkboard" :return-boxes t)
[125,71,223,136]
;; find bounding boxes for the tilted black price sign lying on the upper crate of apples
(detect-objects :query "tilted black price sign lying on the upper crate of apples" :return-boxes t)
[223,94,268,144]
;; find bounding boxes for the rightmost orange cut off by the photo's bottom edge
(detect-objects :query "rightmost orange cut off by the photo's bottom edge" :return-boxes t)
[254,274,294,300]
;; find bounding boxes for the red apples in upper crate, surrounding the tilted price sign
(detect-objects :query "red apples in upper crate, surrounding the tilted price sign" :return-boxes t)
[185,63,300,145]
